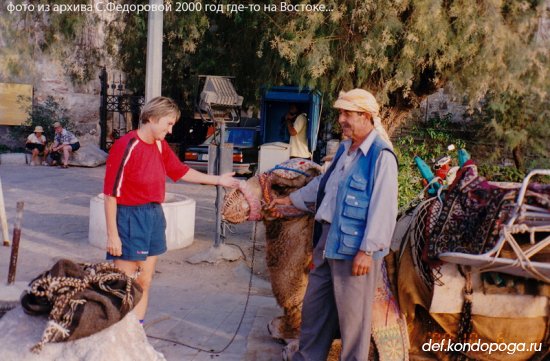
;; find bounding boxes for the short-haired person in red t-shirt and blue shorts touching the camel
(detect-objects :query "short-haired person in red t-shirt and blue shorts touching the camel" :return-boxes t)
[103,97,239,322]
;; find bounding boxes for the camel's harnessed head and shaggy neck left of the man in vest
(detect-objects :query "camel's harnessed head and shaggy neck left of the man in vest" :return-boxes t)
[222,158,321,340]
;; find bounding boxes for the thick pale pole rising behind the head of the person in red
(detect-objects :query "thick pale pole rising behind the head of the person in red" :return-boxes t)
[145,0,164,102]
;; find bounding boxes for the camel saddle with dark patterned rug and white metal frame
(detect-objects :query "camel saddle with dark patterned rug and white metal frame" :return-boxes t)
[436,164,550,283]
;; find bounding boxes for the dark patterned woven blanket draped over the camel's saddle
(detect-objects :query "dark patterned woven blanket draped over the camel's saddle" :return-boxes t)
[426,161,550,260]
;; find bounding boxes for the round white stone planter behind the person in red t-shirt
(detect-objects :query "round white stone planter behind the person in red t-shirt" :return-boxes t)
[88,193,196,251]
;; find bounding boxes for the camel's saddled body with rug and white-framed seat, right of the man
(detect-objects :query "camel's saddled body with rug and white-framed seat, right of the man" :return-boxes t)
[394,161,550,360]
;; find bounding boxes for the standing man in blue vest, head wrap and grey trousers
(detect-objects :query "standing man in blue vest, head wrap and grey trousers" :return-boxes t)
[270,89,397,361]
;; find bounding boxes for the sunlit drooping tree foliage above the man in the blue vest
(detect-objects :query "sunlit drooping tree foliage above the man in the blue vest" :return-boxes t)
[264,0,550,128]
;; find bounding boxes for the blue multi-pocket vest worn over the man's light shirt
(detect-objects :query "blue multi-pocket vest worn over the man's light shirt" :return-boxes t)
[313,135,395,259]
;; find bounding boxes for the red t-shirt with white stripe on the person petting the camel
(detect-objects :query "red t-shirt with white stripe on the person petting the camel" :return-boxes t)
[103,131,189,206]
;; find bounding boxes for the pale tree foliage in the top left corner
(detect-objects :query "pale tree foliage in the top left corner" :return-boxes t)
[0,0,104,85]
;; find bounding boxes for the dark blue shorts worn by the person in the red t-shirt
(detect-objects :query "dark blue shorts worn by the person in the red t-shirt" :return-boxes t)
[107,203,166,261]
